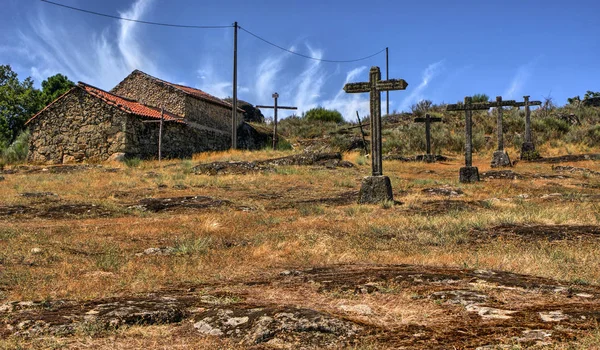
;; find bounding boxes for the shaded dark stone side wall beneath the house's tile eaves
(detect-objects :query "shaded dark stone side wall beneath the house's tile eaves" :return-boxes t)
[125,116,231,159]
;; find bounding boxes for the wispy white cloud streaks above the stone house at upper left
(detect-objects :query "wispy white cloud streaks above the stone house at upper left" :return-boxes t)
[16,0,158,89]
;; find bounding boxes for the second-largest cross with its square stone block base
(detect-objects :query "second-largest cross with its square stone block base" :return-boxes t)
[446,96,514,182]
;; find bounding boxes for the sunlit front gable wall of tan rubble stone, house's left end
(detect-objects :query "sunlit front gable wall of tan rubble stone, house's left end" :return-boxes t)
[28,88,127,164]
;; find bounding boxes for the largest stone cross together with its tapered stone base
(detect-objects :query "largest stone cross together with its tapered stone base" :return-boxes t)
[344,67,408,203]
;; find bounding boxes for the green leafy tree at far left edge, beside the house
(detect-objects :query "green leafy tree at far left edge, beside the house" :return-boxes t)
[0,65,42,148]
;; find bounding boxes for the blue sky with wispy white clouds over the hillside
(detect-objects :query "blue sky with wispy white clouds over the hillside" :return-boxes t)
[0,0,600,120]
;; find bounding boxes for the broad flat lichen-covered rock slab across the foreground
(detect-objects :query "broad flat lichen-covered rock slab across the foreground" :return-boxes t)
[0,264,600,349]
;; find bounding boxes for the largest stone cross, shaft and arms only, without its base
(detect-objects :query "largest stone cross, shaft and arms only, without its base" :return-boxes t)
[344,67,408,176]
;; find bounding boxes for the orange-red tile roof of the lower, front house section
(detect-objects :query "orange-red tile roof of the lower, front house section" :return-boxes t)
[25,82,187,125]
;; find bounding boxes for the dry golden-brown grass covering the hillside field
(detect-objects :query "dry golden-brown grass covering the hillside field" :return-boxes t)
[0,145,600,349]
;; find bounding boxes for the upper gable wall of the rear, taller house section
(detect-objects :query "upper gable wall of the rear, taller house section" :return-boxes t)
[110,71,189,117]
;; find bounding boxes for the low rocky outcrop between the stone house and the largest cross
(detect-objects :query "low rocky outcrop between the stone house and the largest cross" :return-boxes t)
[194,153,354,175]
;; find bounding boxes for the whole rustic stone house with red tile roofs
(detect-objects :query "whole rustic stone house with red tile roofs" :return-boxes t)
[26,70,263,164]
